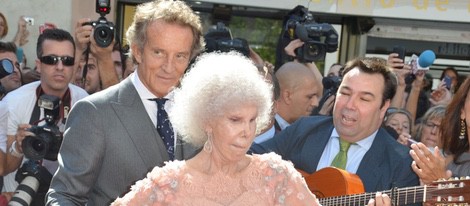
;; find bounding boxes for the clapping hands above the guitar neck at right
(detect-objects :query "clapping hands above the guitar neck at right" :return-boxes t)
[410,143,452,185]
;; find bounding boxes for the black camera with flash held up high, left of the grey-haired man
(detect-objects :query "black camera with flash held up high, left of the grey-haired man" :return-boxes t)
[83,0,114,48]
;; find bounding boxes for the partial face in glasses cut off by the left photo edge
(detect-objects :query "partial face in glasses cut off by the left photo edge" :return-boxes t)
[0,50,21,92]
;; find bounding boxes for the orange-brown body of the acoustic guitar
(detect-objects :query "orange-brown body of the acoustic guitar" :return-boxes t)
[299,167,365,198]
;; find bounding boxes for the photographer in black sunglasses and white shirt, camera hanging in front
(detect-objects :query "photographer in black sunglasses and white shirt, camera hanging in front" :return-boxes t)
[4,29,88,205]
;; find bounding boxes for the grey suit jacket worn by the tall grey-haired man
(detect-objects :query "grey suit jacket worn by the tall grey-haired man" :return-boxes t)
[47,78,195,206]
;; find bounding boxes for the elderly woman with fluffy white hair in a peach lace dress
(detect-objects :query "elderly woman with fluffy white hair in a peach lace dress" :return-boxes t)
[113,53,389,205]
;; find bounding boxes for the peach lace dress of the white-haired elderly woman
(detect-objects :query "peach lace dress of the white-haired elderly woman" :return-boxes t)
[112,153,316,206]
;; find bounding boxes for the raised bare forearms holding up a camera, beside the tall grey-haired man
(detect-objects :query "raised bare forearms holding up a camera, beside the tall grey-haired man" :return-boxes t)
[74,18,119,89]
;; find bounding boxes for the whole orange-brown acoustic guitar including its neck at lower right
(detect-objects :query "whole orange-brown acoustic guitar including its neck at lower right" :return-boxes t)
[298,167,470,206]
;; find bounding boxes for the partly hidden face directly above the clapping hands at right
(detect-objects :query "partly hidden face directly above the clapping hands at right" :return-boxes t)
[421,118,442,147]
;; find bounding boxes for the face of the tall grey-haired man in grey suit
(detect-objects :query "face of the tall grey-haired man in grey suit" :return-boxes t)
[132,20,193,97]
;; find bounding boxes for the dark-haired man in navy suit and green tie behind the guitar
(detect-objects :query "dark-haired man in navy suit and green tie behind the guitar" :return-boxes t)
[250,58,419,192]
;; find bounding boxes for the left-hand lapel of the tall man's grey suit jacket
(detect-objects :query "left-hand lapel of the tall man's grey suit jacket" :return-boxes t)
[112,78,169,168]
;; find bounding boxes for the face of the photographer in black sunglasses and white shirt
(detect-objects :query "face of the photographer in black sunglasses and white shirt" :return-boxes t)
[36,40,74,97]
